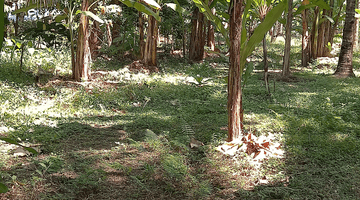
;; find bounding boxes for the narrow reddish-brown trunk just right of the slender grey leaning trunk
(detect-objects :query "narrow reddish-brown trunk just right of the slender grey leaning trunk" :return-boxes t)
[301,5,311,67]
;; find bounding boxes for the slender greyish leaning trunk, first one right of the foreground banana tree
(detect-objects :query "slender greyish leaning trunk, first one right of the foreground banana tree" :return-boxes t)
[282,0,293,77]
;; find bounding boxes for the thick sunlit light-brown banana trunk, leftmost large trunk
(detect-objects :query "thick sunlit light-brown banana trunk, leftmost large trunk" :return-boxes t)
[73,0,91,81]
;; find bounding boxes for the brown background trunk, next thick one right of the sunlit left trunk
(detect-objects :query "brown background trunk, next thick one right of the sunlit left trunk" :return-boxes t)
[143,16,158,67]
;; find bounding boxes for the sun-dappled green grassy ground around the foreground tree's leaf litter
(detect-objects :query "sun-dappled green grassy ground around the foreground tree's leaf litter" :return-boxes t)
[0,38,360,199]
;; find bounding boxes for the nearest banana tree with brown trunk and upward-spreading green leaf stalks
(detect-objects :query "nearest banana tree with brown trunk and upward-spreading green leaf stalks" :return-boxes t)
[193,0,287,141]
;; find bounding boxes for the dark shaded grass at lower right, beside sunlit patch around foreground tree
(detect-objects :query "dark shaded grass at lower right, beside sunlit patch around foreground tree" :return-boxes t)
[236,75,360,199]
